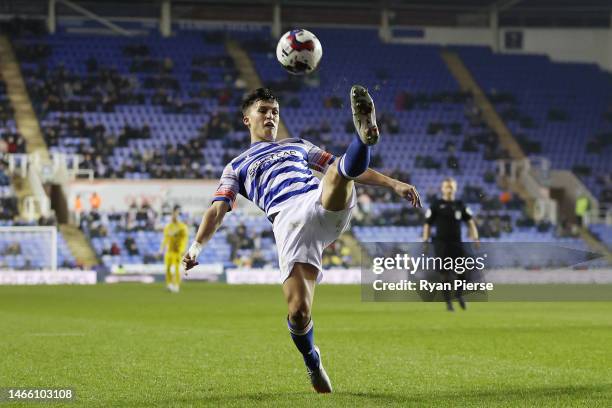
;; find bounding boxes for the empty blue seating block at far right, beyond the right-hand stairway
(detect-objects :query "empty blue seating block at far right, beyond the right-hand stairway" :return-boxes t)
[457,47,612,204]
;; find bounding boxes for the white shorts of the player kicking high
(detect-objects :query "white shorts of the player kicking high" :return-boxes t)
[272,183,357,283]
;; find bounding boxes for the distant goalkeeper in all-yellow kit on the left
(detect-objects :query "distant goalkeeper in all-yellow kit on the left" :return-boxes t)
[159,207,189,293]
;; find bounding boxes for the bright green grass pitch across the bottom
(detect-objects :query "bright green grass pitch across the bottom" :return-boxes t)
[0,283,612,407]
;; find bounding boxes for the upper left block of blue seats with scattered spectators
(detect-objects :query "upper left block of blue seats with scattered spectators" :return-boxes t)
[15,25,244,179]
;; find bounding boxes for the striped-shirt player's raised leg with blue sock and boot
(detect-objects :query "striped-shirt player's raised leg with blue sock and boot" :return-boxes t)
[321,85,380,211]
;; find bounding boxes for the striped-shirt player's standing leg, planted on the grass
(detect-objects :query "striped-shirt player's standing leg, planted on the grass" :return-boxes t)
[283,263,332,393]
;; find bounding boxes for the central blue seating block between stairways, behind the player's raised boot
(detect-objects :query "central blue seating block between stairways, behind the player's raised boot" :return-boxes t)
[238,29,585,253]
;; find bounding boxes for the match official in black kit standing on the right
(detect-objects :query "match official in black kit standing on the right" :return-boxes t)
[423,177,478,311]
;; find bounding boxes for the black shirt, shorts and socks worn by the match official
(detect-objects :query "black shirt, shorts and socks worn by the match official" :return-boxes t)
[425,199,472,308]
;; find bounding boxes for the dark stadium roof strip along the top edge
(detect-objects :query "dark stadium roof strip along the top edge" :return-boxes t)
[0,0,612,27]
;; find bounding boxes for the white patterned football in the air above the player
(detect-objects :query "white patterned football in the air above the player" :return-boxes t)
[276,29,323,75]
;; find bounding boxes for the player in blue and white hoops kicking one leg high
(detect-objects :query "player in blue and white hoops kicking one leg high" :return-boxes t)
[183,85,421,393]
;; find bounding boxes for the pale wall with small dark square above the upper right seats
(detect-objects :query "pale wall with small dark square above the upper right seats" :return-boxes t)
[392,27,612,72]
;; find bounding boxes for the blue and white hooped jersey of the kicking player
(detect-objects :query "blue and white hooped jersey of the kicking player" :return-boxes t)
[213,138,336,216]
